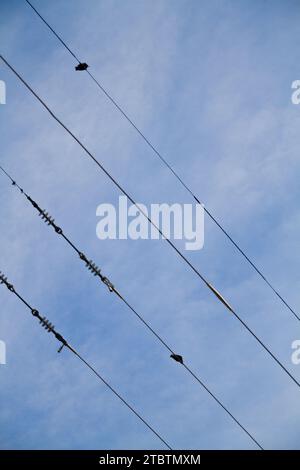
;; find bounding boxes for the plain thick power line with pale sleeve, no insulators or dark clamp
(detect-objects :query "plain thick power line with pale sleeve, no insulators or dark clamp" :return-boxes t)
[0,55,300,388]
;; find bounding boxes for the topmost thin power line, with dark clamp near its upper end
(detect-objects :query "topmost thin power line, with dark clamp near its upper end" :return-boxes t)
[25,0,300,321]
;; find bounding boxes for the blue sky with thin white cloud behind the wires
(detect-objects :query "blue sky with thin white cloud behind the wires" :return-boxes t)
[0,0,300,449]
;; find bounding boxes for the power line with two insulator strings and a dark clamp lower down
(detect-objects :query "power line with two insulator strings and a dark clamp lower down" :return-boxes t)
[0,165,263,450]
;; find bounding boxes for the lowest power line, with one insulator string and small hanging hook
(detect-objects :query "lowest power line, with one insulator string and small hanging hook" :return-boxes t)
[0,272,172,450]
